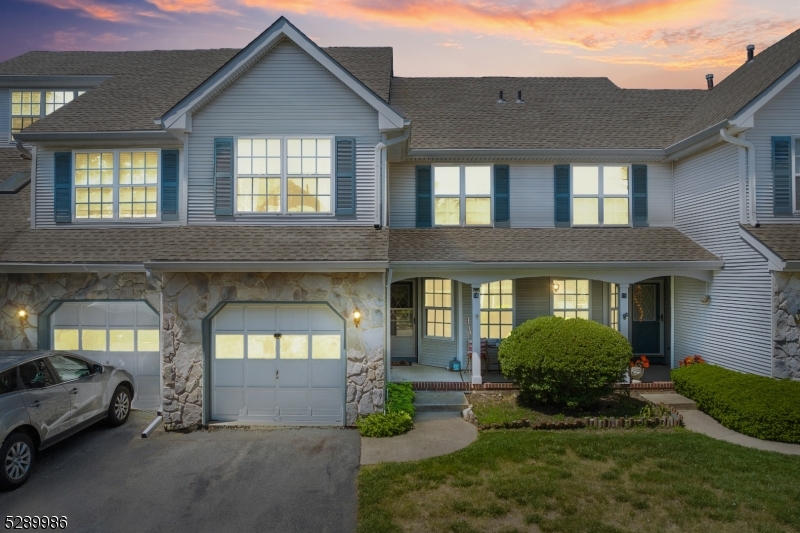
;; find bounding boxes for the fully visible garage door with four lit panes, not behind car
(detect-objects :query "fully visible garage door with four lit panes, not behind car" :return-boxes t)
[211,304,345,425]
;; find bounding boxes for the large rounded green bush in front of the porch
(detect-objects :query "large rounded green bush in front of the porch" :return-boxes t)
[498,316,633,408]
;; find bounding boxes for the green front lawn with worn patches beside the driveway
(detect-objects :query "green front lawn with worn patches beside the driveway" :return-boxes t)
[358,429,800,533]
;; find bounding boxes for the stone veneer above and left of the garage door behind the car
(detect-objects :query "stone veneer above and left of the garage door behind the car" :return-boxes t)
[0,272,161,350]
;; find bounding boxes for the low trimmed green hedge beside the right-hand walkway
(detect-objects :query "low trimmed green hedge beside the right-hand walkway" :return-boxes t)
[672,364,800,442]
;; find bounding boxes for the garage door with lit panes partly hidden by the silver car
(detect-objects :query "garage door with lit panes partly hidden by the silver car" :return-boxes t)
[50,301,161,409]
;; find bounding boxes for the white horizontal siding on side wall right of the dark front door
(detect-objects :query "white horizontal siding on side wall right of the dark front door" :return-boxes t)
[673,144,772,375]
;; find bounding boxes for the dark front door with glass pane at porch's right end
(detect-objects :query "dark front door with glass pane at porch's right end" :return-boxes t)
[630,283,664,358]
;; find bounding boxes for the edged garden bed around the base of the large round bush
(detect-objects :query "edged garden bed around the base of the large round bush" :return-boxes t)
[469,391,647,424]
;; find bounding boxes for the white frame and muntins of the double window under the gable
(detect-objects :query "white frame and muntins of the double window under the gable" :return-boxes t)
[233,135,336,217]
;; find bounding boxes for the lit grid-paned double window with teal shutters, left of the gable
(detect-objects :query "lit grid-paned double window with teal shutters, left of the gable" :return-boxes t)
[73,150,159,220]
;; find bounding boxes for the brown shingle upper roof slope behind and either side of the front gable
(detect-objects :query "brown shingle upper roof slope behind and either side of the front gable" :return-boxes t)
[0,47,392,132]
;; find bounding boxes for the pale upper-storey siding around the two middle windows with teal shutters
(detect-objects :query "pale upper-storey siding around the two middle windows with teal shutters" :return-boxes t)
[389,161,673,229]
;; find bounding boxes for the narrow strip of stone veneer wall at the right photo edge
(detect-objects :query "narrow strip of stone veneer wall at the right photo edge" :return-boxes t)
[772,272,800,379]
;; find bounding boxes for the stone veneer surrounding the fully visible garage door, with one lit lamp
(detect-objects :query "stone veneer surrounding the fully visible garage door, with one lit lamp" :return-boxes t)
[161,273,385,429]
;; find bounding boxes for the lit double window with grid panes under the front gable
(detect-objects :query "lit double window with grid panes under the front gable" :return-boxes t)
[236,137,333,213]
